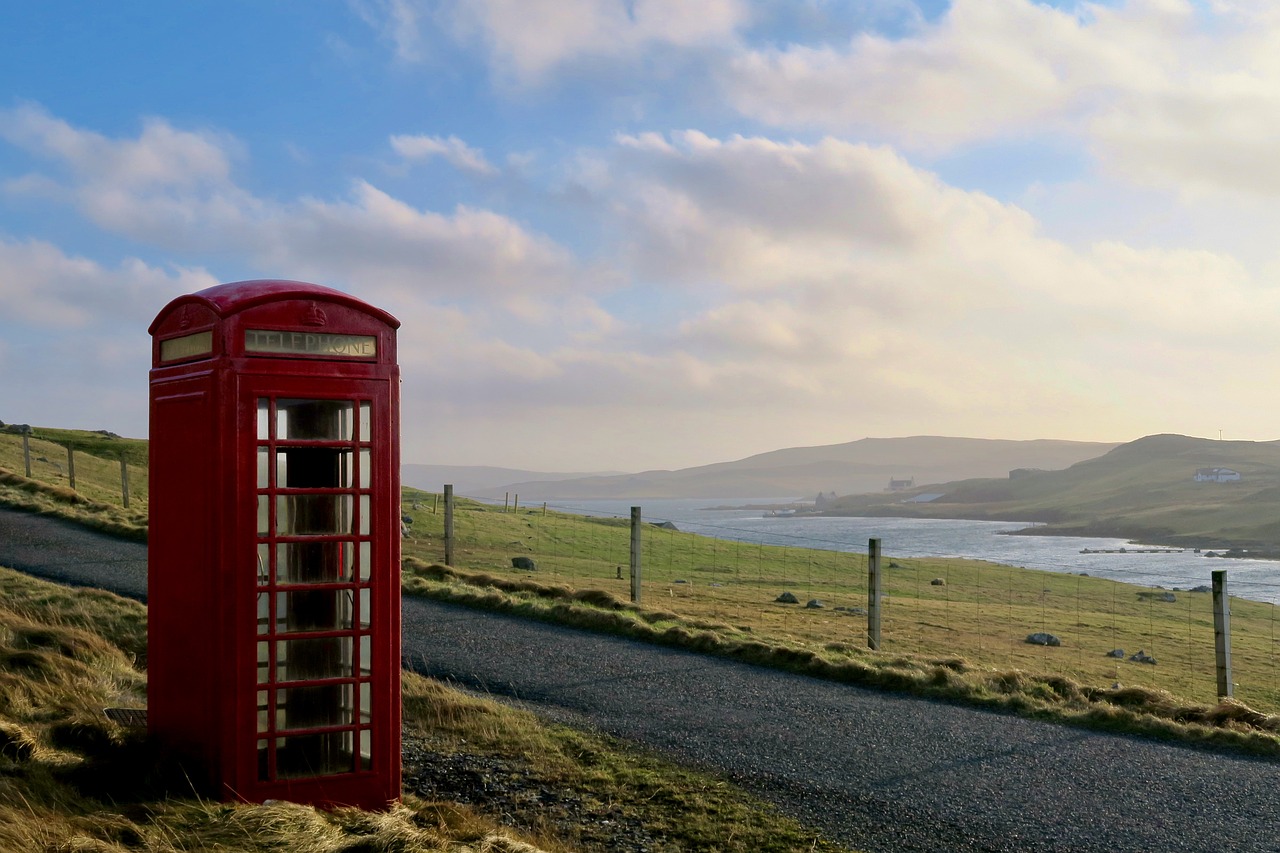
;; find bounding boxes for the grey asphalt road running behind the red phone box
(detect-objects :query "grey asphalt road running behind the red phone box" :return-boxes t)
[0,512,1280,852]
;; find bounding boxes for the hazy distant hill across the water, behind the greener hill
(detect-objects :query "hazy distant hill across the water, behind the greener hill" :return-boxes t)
[477,435,1116,501]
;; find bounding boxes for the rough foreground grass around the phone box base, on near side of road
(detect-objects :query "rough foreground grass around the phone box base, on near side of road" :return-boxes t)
[0,569,860,853]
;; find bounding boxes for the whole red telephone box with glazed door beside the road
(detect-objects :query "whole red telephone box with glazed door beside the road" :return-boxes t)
[147,280,401,808]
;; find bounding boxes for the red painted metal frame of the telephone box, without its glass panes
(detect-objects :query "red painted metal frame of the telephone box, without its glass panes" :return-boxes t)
[147,280,401,808]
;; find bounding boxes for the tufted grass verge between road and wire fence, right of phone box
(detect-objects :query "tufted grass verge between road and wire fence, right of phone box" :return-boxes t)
[404,558,1280,757]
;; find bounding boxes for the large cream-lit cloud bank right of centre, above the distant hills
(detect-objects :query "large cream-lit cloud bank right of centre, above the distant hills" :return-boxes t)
[576,132,1280,445]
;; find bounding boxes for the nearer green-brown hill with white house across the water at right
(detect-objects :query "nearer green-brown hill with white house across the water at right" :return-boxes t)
[829,434,1280,551]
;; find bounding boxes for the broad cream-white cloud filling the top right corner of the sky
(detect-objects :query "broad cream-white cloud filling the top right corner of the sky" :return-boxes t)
[722,0,1280,196]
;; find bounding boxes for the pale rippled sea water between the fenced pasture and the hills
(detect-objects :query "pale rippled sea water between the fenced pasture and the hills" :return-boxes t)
[548,498,1280,603]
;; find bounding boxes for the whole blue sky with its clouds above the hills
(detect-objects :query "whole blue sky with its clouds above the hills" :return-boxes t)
[0,0,1280,471]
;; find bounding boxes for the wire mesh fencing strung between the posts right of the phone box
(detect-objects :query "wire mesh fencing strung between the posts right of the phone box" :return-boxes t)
[406,489,1280,711]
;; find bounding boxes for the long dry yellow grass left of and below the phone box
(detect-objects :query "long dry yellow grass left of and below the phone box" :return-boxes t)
[0,569,563,853]
